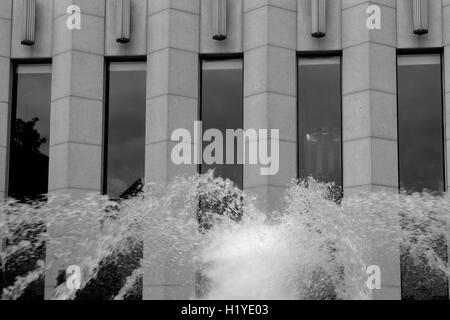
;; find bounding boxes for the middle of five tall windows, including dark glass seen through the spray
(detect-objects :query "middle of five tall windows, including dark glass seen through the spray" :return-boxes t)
[197,59,244,297]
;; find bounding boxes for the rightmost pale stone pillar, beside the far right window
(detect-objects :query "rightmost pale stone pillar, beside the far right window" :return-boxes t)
[342,0,400,299]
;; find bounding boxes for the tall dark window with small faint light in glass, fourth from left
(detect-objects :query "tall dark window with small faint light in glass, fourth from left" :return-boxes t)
[298,57,342,196]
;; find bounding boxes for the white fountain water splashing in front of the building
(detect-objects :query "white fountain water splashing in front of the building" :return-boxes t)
[0,173,450,299]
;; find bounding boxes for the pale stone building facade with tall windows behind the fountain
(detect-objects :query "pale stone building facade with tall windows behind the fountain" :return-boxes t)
[0,0,450,299]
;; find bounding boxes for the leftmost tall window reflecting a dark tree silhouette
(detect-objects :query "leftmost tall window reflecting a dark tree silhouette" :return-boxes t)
[4,64,51,299]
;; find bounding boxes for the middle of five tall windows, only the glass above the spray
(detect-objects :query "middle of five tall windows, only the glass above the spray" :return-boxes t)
[201,59,243,188]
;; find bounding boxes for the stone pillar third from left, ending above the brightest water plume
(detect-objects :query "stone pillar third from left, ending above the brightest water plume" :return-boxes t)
[244,0,297,211]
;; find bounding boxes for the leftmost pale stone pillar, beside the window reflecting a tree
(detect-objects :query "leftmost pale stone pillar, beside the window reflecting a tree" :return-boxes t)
[45,0,105,298]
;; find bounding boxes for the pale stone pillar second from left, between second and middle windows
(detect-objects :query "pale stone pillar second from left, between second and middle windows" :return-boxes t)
[143,0,200,299]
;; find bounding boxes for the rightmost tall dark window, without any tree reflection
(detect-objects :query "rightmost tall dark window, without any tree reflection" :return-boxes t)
[398,55,445,192]
